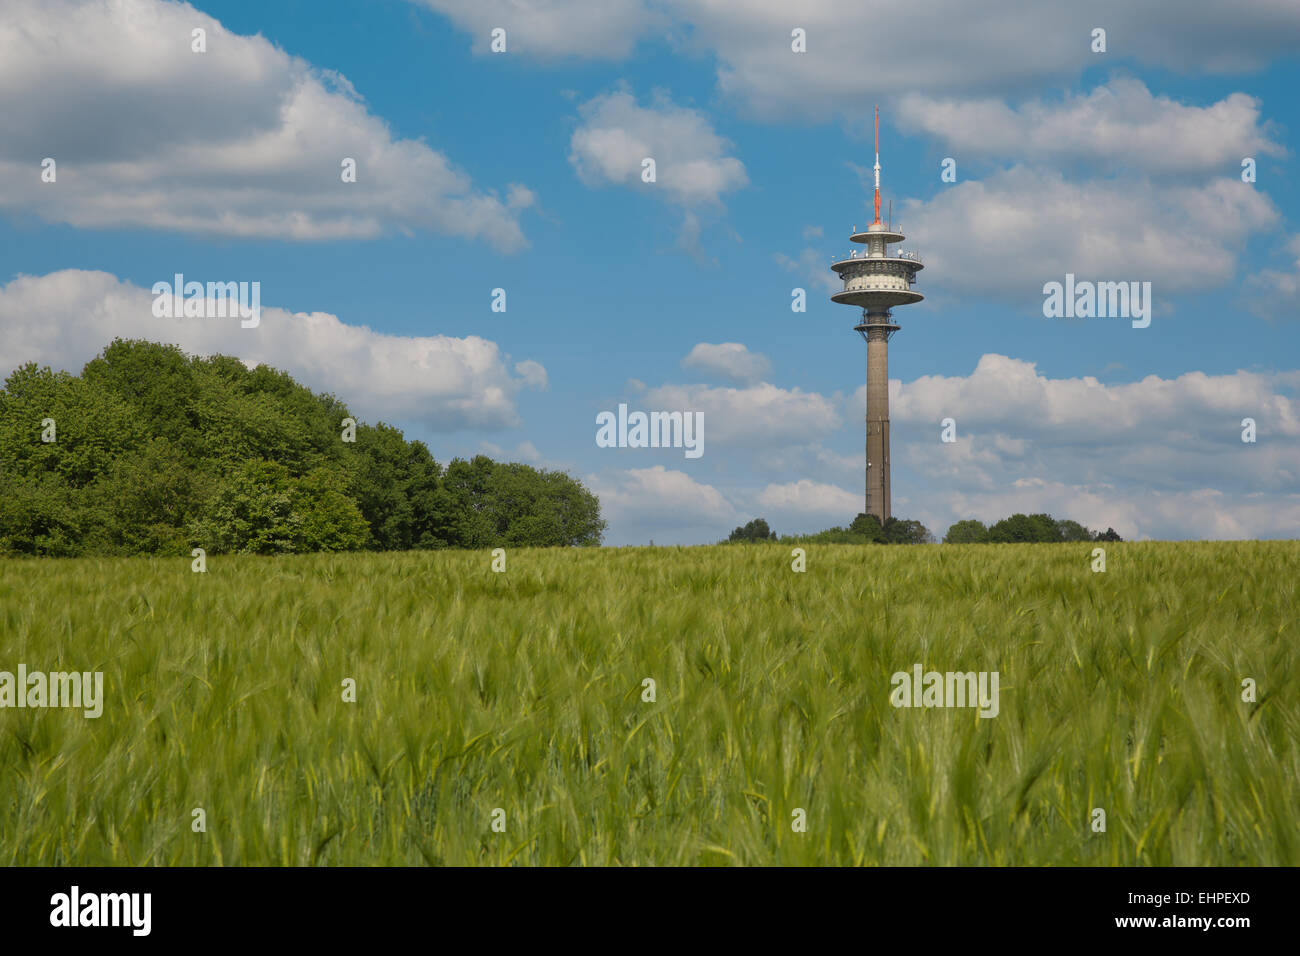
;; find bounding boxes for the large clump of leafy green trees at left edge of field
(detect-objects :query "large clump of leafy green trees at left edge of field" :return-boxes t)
[0,339,606,557]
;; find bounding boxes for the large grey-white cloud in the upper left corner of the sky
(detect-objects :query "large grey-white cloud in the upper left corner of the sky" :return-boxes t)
[0,0,534,251]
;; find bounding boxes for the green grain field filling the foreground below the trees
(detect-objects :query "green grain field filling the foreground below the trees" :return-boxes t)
[0,541,1300,865]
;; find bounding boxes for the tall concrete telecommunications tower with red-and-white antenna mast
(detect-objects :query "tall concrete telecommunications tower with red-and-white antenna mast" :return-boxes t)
[831,109,926,524]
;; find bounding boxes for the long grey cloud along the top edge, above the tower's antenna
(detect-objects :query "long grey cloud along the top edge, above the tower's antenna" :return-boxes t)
[415,0,1300,118]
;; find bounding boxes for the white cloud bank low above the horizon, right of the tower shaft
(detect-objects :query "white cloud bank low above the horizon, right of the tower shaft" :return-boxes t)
[878,354,1300,538]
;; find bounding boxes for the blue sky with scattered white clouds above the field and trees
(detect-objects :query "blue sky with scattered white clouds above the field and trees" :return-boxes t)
[0,0,1300,544]
